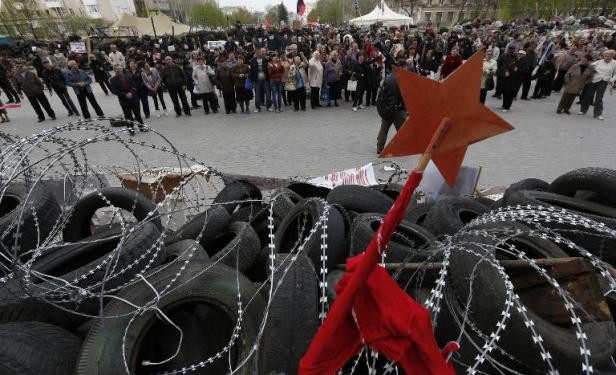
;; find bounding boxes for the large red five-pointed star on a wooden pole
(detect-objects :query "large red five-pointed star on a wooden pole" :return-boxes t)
[379,51,513,186]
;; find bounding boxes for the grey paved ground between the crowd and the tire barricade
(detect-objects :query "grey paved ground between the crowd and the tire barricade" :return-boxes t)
[0,86,616,191]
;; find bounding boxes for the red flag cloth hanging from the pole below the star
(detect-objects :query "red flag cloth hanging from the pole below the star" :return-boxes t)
[298,171,454,375]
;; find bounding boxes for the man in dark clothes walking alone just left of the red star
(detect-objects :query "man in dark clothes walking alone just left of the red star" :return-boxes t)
[376,67,407,154]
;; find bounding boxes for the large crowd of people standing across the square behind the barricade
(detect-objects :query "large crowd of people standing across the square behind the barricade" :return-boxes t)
[0,15,616,142]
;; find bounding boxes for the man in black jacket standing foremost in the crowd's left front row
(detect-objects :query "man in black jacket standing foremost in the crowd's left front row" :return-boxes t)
[109,64,145,136]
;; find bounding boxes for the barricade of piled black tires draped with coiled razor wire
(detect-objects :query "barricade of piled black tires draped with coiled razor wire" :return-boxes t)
[0,168,616,374]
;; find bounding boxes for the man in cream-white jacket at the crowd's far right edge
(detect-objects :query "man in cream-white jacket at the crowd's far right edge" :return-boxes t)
[579,50,616,120]
